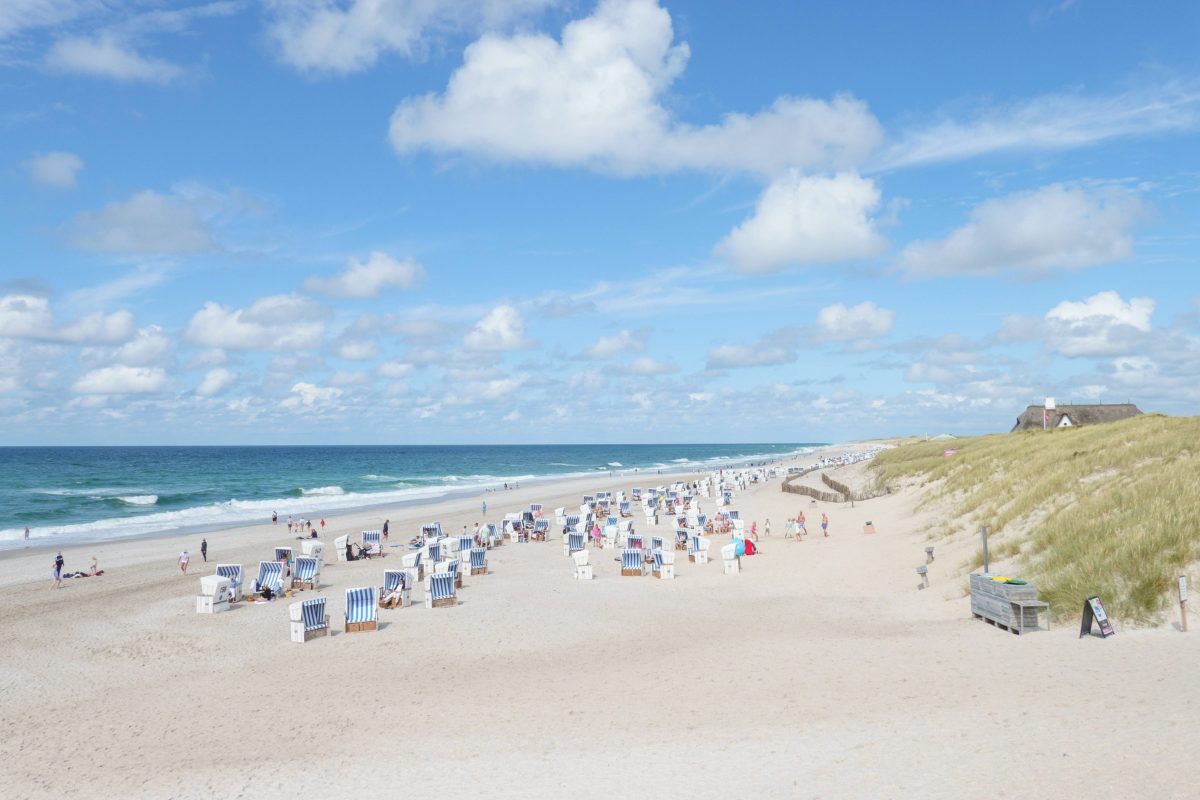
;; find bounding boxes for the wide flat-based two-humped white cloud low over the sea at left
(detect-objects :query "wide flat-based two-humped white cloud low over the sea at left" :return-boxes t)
[184,294,325,350]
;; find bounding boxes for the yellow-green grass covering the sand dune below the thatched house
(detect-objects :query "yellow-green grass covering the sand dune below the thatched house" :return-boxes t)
[872,414,1200,625]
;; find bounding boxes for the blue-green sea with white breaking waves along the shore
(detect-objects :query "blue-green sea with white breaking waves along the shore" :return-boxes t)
[0,443,822,548]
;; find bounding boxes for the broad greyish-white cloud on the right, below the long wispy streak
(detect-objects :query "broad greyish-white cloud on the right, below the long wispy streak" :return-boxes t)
[900,184,1141,277]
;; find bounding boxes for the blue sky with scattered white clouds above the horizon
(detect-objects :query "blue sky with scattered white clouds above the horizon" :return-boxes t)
[0,0,1200,445]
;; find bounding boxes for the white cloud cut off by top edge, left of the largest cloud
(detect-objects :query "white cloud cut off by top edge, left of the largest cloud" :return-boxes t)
[268,0,556,74]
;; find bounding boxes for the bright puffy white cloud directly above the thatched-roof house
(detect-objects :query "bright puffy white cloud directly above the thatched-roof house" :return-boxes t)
[1045,291,1154,356]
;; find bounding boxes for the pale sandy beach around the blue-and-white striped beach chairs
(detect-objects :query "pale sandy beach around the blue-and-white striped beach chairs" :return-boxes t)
[0,448,1200,799]
